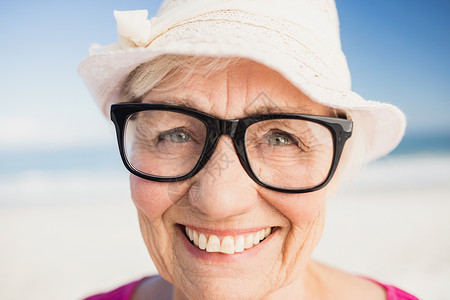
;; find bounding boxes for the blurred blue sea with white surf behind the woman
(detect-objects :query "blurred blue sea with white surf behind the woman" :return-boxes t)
[0,132,450,207]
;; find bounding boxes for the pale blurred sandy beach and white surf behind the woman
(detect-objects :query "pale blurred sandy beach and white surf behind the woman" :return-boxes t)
[0,153,450,300]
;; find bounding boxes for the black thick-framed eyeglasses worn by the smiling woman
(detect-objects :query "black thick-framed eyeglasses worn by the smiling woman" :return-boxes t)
[111,103,352,193]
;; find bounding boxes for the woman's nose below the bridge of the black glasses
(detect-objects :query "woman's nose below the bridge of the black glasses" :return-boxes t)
[189,136,258,219]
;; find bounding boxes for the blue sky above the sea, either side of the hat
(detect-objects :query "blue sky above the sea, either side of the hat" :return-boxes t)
[0,0,450,149]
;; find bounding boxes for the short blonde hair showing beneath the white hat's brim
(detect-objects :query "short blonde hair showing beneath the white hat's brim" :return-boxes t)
[121,54,368,185]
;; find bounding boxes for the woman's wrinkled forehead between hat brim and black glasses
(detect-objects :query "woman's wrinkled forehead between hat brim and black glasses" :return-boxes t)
[142,60,330,119]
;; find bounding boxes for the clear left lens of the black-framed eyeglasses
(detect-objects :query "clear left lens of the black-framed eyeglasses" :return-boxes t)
[125,110,206,177]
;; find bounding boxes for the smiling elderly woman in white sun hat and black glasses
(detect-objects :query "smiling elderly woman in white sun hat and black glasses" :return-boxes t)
[79,0,417,299]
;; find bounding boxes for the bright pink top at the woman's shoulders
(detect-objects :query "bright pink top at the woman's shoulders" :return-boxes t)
[84,277,419,300]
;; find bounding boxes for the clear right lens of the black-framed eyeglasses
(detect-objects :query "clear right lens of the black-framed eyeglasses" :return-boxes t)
[245,119,333,189]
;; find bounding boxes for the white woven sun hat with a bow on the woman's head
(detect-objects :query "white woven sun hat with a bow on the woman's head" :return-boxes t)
[79,0,406,161]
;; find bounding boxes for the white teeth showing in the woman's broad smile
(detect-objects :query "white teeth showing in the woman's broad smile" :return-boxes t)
[184,226,275,254]
